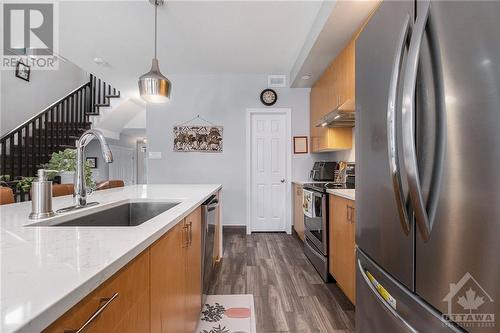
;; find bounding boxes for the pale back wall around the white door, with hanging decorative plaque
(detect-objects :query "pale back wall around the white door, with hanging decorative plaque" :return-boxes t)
[146,75,316,225]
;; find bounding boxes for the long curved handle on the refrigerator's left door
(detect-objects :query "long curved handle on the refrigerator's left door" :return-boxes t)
[387,14,411,235]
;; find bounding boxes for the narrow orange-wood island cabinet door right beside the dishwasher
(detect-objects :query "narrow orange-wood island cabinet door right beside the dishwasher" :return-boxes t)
[184,207,202,333]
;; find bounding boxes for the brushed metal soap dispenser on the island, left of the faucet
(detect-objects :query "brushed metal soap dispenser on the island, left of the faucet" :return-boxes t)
[29,169,58,220]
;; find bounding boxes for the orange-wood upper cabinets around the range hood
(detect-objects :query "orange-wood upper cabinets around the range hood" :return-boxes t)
[310,39,355,153]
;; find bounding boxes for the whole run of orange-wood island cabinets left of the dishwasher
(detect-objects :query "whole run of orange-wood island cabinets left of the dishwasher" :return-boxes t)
[44,207,202,333]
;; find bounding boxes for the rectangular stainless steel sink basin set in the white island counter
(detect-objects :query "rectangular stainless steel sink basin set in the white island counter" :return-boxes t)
[34,201,179,227]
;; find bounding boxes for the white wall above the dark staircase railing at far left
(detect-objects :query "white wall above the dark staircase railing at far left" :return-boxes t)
[0,61,88,135]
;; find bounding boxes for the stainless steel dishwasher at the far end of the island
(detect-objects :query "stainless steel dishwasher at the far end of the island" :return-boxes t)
[201,195,219,302]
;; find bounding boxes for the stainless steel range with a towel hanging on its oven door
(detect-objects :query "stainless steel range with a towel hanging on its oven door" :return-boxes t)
[303,183,354,282]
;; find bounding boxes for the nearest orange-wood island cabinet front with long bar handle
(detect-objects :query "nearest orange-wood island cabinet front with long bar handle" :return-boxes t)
[44,249,150,333]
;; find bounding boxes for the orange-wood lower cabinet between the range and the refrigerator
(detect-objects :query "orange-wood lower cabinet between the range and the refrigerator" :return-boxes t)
[328,194,356,304]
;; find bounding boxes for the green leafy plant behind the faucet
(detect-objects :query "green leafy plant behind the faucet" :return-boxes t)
[44,149,95,190]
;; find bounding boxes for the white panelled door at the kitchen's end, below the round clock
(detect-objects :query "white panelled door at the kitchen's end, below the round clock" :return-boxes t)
[250,113,287,231]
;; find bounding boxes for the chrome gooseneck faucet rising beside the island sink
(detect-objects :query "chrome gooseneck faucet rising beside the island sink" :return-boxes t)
[73,129,113,207]
